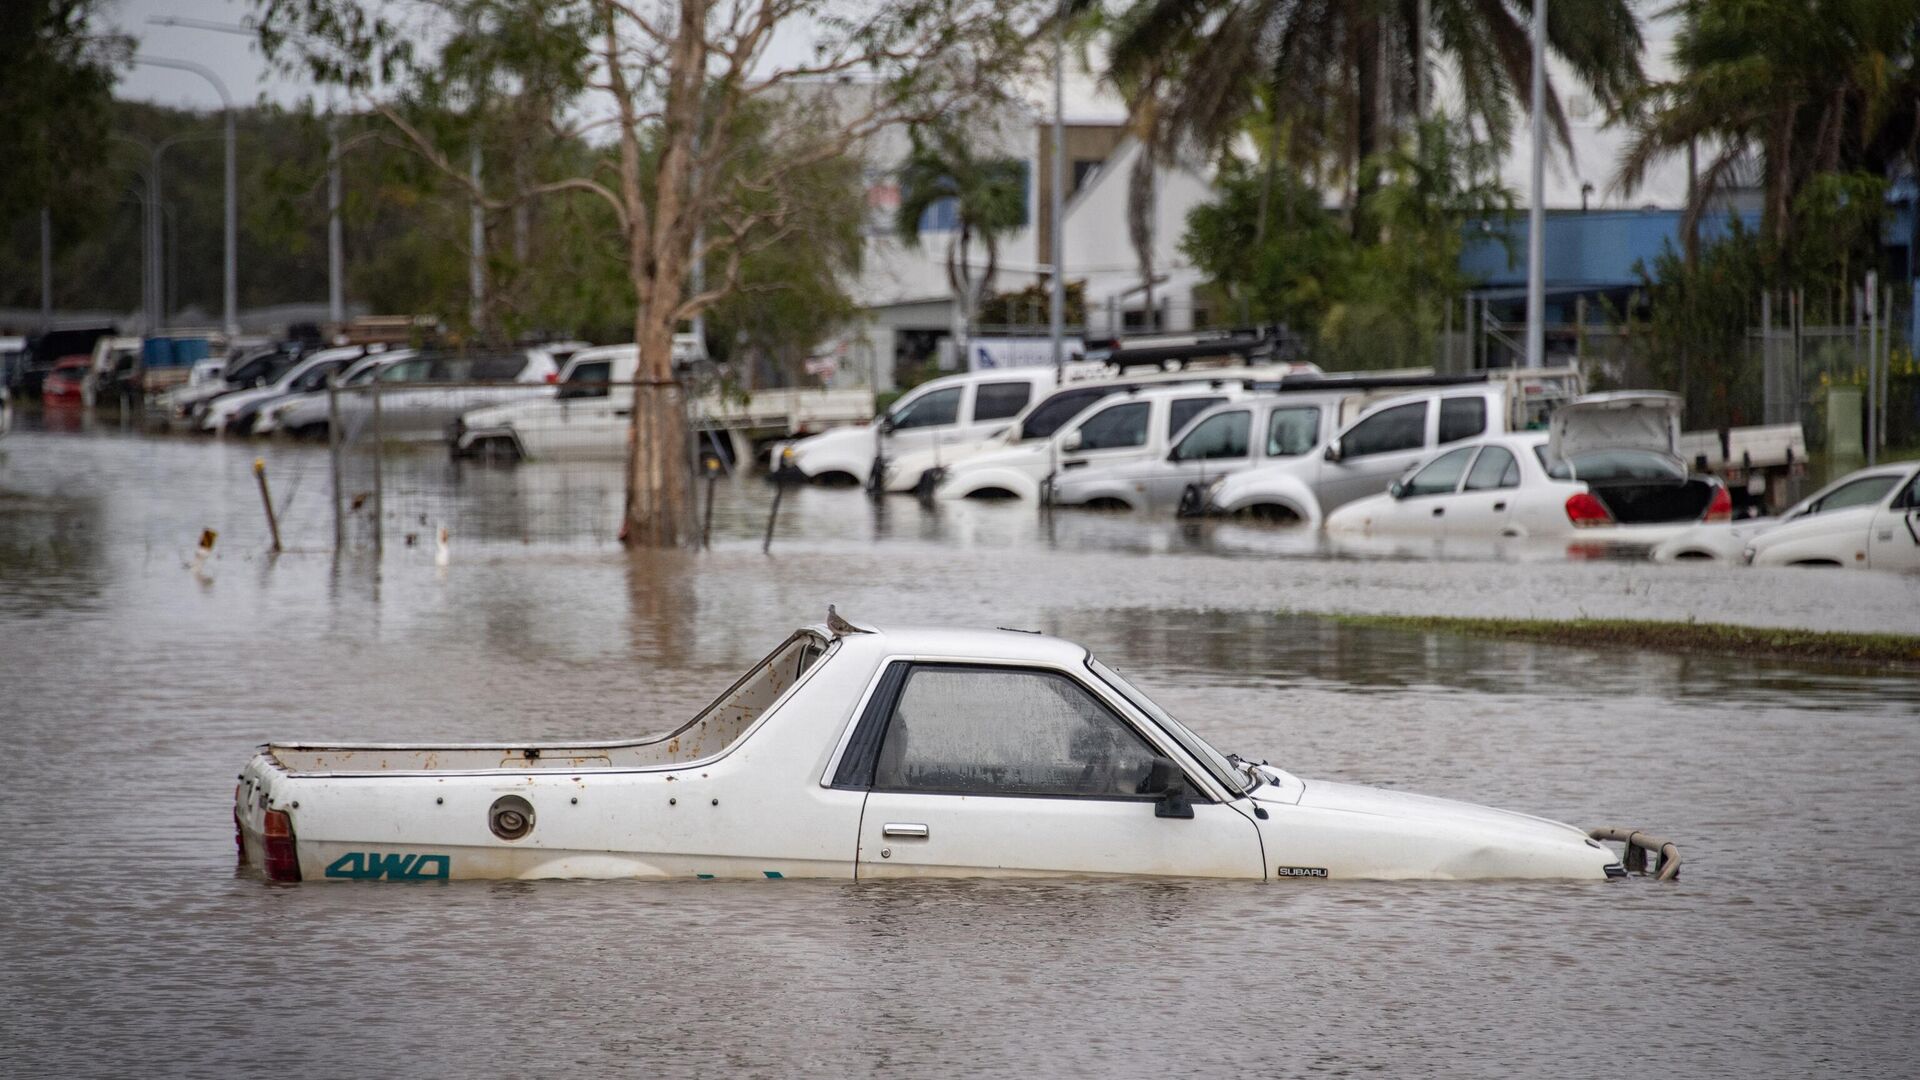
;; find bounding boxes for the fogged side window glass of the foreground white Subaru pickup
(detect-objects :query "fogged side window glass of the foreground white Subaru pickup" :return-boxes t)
[874,665,1156,798]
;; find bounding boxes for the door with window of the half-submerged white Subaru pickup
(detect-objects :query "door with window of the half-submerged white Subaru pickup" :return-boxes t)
[835,661,1265,878]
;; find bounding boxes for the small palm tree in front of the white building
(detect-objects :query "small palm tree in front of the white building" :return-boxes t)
[895,125,1027,348]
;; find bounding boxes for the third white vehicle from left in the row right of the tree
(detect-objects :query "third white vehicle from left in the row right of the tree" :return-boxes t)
[929,382,1246,500]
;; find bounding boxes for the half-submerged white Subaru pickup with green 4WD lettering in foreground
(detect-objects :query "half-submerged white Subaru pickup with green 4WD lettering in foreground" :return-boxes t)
[234,609,1678,882]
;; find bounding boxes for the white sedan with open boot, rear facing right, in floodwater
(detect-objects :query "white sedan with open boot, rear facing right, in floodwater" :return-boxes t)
[1327,432,1734,546]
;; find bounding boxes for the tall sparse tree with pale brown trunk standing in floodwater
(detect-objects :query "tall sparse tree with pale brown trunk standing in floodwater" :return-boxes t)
[255,0,1035,546]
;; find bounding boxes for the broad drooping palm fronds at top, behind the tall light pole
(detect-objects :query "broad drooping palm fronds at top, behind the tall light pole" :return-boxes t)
[1110,0,1644,216]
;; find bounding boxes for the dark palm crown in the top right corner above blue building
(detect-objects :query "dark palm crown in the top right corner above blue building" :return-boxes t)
[1615,0,1920,250]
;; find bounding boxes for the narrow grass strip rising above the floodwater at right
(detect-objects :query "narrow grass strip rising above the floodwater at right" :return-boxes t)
[1327,615,1920,669]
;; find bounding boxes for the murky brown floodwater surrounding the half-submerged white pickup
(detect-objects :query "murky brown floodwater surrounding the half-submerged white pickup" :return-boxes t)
[0,430,1920,1076]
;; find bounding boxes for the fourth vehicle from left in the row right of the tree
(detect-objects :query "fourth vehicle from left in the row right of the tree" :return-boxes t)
[1048,380,1436,509]
